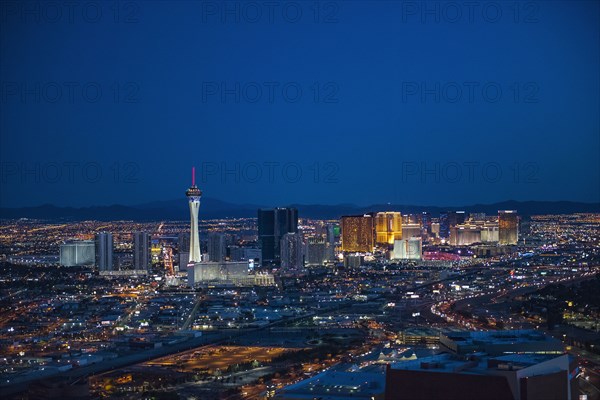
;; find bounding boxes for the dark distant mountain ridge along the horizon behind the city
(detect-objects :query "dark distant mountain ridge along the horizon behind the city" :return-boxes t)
[0,197,600,221]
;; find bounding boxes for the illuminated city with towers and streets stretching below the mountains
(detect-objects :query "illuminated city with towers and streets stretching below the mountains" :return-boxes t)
[0,185,600,399]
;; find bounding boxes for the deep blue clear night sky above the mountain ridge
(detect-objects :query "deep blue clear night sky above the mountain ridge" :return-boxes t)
[0,1,600,207]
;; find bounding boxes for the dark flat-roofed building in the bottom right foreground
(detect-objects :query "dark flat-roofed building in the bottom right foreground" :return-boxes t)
[385,354,577,400]
